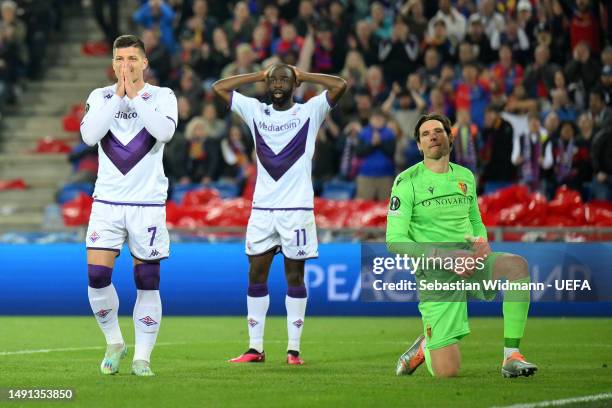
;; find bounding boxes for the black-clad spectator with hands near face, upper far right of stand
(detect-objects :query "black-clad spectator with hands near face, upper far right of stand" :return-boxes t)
[563,42,601,109]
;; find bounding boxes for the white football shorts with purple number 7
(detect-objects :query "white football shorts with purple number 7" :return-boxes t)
[85,200,170,262]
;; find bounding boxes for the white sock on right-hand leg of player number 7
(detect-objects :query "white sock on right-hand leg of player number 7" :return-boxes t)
[134,290,162,361]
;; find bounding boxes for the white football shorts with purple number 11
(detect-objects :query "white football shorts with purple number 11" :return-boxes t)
[246,208,319,260]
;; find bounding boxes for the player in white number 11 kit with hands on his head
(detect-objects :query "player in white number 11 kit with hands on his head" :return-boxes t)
[213,64,347,365]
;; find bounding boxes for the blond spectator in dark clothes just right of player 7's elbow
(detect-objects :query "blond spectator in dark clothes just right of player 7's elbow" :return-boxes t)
[185,117,221,184]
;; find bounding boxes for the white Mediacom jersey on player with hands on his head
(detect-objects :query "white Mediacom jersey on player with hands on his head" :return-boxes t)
[231,91,331,209]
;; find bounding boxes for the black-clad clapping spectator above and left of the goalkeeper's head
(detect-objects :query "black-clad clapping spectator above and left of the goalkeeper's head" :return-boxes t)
[379,18,419,83]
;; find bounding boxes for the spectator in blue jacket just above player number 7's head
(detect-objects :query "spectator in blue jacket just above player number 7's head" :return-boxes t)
[132,0,176,54]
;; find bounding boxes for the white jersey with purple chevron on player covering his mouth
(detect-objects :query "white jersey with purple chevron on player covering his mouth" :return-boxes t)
[83,84,178,204]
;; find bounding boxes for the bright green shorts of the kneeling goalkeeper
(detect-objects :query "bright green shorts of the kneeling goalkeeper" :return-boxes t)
[419,252,501,350]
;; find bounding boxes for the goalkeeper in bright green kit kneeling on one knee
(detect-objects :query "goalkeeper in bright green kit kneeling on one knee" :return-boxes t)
[386,114,537,377]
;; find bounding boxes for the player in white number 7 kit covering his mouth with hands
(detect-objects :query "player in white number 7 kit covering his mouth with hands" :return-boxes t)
[81,35,177,376]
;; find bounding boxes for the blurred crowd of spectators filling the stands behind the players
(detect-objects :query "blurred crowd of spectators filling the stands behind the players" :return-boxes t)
[73,0,612,200]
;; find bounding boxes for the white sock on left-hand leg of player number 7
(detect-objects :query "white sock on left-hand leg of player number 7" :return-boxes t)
[87,283,123,344]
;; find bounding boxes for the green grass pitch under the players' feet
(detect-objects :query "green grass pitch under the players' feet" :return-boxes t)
[0,317,612,408]
